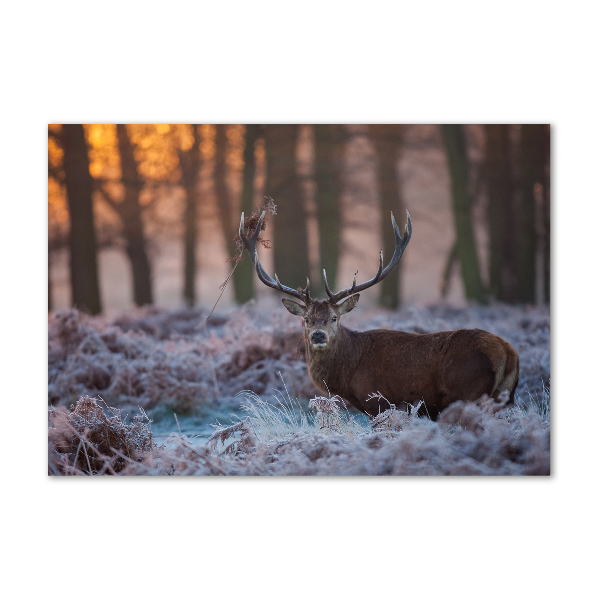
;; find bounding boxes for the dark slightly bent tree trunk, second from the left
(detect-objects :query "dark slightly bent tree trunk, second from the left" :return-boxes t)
[115,125,153,306]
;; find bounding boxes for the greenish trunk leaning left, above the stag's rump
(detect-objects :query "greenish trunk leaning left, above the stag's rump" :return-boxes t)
[441,125,485,302]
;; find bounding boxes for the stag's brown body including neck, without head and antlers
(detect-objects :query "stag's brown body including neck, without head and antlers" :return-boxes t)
[306,301,519,419]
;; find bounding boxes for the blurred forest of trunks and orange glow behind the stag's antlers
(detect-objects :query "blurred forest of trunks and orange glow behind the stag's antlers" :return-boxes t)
[48,124,550,314]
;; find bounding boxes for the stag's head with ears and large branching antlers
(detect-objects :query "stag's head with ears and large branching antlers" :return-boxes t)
[239,211,412,351]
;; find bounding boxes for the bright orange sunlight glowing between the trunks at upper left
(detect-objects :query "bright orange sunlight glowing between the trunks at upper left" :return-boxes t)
[48,124,258,310]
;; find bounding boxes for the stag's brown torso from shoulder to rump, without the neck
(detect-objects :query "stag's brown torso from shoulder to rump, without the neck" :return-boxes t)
[338,329,518,417]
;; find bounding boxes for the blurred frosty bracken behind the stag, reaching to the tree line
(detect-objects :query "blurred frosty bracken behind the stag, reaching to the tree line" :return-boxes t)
[48,305,550,414]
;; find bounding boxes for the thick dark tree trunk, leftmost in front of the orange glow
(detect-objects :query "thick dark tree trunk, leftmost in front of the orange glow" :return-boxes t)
[61,125,102,315]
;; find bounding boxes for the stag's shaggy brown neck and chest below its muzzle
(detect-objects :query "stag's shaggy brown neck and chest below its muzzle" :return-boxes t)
[306,326,362,398]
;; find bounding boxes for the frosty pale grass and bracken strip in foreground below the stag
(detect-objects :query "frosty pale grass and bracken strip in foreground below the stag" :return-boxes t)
[49,396,550,475]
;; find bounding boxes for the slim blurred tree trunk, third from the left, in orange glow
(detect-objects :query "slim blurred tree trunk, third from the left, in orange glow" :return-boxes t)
[179,125,201,306]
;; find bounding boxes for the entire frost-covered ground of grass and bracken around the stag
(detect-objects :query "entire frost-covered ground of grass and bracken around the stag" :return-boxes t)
[48,302,550,475]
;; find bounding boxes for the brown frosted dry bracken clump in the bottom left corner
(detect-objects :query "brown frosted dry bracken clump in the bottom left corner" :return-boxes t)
[48,396,156,475]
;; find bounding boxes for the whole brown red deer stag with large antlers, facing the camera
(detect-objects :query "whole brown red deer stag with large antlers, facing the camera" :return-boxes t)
[239,211,519,419]
